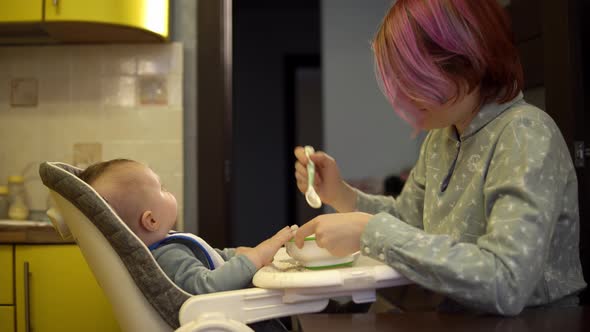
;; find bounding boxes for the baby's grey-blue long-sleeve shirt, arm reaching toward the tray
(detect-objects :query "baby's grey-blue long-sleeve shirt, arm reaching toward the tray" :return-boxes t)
[152,243,256,295]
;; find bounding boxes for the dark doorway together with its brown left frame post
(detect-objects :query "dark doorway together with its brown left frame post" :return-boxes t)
[197,0,321,247]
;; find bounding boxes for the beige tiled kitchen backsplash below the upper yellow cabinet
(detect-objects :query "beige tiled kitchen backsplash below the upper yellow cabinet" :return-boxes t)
[0,43,183,228]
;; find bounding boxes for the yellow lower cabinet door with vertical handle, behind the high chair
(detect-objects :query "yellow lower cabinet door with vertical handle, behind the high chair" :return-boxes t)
[14,244,120,332]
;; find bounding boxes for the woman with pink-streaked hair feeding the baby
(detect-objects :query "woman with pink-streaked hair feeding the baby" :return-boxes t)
[295,0,586,315]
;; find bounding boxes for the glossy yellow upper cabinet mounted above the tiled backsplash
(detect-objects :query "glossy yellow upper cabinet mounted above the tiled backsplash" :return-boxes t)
[0,0,169,44]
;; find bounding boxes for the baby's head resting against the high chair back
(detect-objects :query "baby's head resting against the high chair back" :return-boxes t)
[79,159,177,246]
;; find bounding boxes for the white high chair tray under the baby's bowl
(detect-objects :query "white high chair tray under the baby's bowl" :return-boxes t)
[253,248,411,289]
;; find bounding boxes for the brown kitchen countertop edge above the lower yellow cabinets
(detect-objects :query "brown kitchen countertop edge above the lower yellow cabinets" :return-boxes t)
[0,220,74,244]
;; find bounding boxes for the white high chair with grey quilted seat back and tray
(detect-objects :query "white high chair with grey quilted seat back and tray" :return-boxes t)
[39,162,409,332]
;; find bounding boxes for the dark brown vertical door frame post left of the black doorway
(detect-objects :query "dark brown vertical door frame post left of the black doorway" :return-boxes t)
[197,0,233,248]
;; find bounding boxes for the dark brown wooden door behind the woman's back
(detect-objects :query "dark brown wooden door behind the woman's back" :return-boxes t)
[507,0,590,305]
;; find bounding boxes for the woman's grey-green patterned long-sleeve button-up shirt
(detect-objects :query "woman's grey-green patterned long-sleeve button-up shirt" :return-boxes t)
[357,94,586,315]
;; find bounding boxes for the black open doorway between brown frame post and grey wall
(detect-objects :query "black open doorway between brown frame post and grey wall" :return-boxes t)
[232,0,321,246]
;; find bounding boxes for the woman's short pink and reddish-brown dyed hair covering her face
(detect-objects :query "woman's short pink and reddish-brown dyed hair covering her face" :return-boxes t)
[373,0,523,127]
